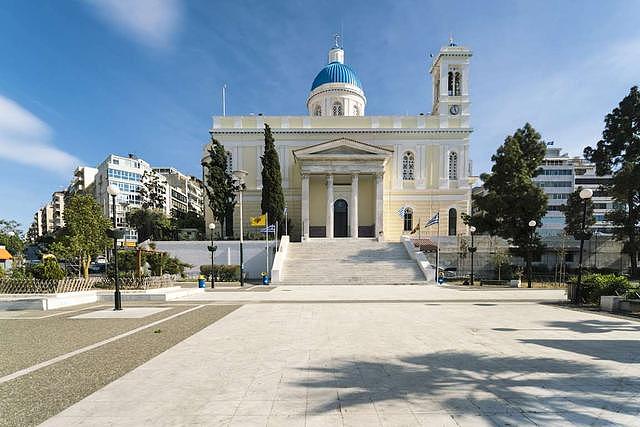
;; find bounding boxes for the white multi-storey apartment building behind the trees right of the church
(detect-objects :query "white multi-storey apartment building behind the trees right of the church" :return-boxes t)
[534,146,614,236]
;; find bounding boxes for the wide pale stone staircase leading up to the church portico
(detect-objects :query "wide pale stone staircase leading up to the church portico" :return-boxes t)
[280,239,426,285]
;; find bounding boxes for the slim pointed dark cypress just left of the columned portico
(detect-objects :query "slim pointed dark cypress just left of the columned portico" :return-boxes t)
[260,123,284,230]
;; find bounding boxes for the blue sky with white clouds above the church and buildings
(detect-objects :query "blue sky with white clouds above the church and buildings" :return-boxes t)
[0,0,640,228]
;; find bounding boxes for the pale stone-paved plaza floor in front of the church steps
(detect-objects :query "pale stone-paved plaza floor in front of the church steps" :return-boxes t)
[44,286,640,426]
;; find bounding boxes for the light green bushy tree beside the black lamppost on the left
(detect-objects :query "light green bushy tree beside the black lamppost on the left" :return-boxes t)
[51,193,112,279]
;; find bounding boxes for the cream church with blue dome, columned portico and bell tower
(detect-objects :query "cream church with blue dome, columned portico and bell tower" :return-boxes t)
[204,43,474,241]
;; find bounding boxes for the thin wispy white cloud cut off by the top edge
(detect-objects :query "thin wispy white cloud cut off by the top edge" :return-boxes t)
[87,0,182,48]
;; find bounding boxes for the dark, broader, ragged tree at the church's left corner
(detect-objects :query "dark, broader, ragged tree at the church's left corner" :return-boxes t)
[202,137,238,235]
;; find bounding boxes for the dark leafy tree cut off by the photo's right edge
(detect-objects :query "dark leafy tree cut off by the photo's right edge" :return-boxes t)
[584,86,640,277]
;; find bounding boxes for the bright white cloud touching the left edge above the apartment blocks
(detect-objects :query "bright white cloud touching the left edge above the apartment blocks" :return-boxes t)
[0,95,81,175]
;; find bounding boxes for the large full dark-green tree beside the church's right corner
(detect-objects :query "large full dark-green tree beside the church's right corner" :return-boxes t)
[465,123,547,284]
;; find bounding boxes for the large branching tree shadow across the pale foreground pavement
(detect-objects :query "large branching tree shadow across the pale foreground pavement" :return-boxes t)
[298,352,640,425]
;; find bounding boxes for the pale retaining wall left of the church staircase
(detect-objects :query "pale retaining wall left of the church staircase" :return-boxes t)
[155,240,275,279]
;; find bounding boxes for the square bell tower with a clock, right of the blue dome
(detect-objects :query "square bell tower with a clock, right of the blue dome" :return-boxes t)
[429,38,472,126]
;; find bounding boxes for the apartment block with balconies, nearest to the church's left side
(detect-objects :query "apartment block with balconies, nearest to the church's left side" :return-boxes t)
[153,167,204,215]
